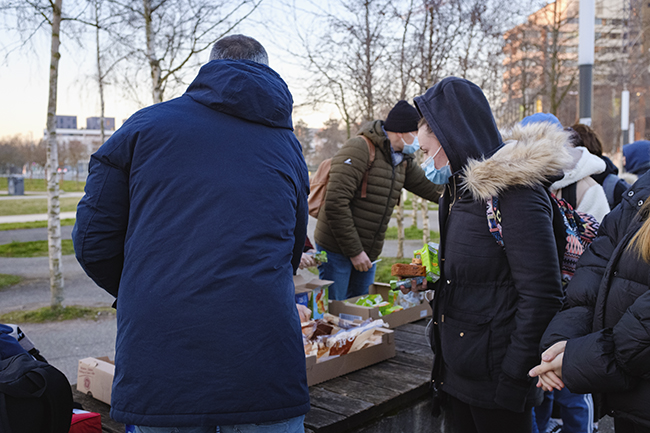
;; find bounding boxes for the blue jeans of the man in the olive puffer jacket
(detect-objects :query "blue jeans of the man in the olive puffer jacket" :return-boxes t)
[316,245,377,301]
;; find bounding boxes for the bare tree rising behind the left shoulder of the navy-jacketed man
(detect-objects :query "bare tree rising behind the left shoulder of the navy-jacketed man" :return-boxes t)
[110,0,262,103]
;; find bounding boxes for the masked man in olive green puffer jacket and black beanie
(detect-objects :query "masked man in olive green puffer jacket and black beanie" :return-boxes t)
[314,101,442,300]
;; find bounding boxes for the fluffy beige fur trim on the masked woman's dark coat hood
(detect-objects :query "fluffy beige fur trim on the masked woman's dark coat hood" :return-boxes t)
[461,122,572,200]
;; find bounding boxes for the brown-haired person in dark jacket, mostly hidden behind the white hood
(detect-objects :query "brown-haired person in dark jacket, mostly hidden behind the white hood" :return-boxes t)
[571,123,630,209]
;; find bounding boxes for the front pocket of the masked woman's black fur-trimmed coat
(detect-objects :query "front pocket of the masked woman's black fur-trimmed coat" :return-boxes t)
[440,314,492,380]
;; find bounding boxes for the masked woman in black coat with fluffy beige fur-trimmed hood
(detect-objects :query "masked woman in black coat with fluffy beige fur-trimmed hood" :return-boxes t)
[414,77,570,433]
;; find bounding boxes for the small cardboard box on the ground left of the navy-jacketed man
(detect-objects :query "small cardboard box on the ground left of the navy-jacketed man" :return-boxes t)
[77,356,115,404]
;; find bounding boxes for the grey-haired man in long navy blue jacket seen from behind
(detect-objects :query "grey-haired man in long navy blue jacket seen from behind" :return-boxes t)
[73,35,309,432]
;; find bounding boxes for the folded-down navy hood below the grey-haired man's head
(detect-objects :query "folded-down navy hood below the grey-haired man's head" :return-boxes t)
[185,60,293,129]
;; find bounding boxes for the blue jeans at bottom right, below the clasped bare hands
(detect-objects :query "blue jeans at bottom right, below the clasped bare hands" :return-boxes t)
[533,388,594,433]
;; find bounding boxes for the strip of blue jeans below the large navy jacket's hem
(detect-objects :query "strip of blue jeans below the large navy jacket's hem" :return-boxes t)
[135,415,305,433]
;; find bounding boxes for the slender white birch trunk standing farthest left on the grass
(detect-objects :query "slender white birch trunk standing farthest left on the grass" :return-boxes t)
[46,0,63,308]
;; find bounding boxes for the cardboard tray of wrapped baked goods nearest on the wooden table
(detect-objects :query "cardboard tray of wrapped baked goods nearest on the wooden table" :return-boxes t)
[306,329,395,386]
